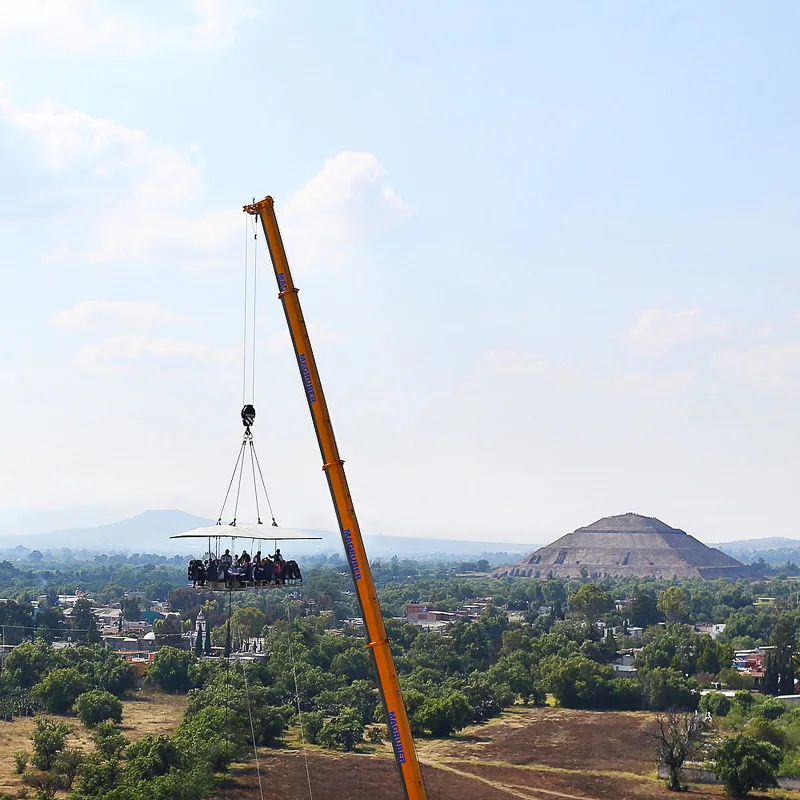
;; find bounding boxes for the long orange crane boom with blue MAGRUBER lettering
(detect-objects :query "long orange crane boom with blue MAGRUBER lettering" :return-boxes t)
[244,197,428,800]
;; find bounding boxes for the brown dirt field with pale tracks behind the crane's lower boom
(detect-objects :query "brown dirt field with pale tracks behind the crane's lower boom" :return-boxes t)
[218,708,800,800]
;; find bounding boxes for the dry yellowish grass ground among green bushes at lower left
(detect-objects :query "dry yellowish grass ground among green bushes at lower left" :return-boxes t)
[0,691,186,796]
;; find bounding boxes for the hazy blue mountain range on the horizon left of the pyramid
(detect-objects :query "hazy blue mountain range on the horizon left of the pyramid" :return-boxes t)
[0,510,536,559]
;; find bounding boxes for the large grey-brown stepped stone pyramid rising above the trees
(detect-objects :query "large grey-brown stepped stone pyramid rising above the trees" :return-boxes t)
[495,514,752,580]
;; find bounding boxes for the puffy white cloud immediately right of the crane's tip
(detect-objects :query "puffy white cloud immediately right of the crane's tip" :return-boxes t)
[280,151,412,266]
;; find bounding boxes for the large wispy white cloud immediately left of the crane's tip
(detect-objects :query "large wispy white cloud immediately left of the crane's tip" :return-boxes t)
[0,85,244,266]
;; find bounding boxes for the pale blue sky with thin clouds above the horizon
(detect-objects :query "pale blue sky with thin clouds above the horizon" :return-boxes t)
[0,0,800,542]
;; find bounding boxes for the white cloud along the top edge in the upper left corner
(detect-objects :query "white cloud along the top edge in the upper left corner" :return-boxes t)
[0,0,258,54]
